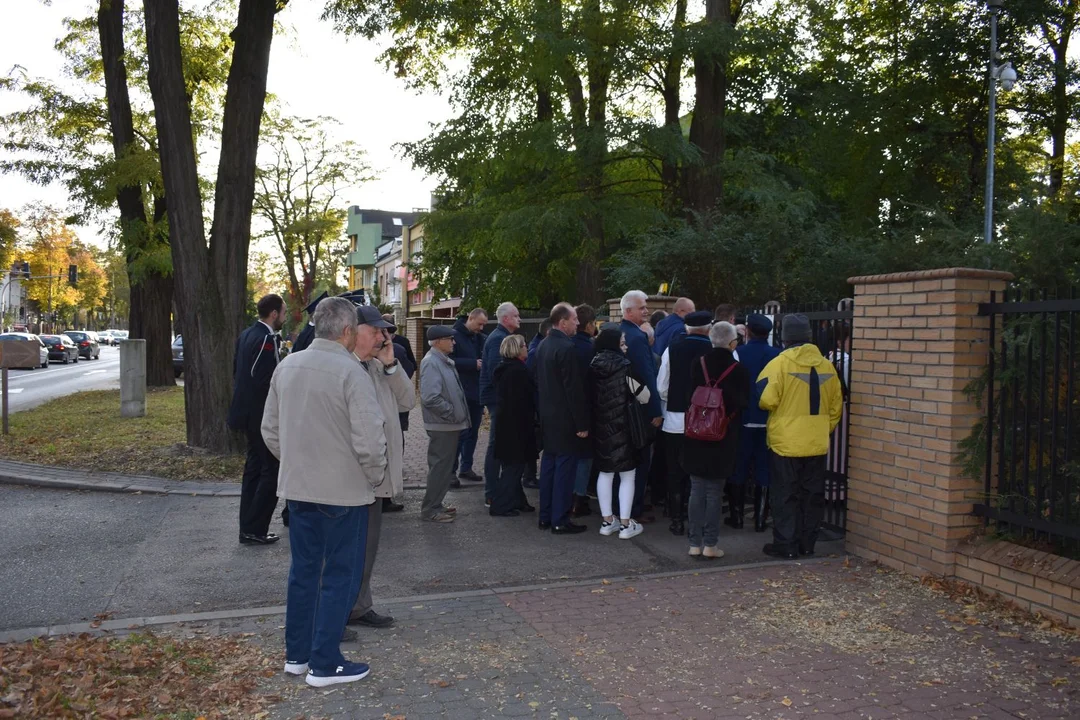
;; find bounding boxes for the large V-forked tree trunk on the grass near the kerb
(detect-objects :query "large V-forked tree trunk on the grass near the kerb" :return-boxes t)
[145,0,285,451]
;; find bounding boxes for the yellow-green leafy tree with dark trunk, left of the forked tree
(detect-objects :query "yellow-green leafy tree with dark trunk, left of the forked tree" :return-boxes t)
[0,0,230,385]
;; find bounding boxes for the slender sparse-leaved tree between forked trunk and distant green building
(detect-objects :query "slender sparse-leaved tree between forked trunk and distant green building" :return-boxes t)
[255,113,370,322]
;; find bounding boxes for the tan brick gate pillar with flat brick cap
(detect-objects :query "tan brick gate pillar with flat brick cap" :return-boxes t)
[847,268,1012,576]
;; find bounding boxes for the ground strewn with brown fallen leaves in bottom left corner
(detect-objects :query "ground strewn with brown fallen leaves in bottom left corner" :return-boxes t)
[0,633,279,720]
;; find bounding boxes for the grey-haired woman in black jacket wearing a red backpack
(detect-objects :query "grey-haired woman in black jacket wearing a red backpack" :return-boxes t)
[683,323,750,558]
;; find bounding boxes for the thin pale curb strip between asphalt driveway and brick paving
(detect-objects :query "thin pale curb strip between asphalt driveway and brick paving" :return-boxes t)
[0,553,848,643]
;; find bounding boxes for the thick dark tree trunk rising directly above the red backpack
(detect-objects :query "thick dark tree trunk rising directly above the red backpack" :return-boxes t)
[684,0,737,213]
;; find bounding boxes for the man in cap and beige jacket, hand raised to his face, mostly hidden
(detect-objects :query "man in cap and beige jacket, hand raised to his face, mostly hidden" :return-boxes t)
[349,313,416,627]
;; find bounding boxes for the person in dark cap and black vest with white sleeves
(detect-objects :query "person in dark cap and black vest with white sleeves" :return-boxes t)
[657,310,713,535]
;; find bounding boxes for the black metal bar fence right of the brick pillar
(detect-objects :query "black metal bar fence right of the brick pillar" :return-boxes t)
[975,288,1080,556]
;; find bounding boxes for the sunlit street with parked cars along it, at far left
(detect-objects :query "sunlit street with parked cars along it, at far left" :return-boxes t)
[8,347,120,412]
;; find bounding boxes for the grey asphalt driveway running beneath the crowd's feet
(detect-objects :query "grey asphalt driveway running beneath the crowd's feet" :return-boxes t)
[0,483,841,629]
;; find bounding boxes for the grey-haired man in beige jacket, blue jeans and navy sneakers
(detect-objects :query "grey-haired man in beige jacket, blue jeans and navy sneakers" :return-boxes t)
[261,298,389,688]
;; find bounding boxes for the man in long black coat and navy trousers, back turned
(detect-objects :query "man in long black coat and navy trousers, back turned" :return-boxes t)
[536,302,590,534]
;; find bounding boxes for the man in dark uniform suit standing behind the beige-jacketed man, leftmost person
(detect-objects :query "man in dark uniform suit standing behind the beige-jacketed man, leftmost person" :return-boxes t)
[228,295,286,545]
